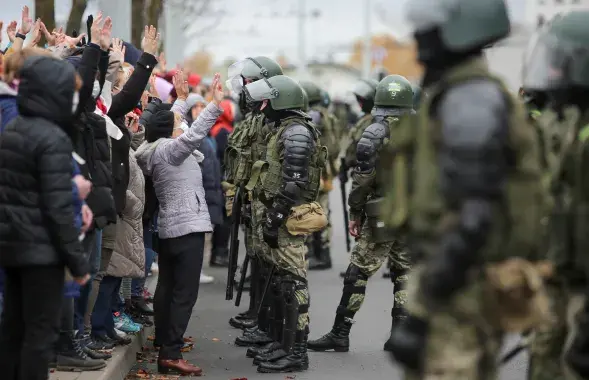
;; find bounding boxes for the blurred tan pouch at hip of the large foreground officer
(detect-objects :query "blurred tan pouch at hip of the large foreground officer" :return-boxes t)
[484,258,553,332]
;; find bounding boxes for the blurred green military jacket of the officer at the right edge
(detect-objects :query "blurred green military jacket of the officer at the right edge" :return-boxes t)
[535,107,589,284]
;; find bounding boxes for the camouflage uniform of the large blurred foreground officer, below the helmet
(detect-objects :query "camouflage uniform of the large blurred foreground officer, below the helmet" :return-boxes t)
[382,58,547,380]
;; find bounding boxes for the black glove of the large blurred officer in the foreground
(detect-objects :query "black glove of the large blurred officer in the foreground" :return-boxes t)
[390,315,429,372]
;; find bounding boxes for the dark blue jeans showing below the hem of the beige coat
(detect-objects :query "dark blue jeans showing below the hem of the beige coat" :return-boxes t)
[92,276,122,335]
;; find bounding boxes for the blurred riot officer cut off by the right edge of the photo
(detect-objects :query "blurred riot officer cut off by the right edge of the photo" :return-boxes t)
[523,11,589,380]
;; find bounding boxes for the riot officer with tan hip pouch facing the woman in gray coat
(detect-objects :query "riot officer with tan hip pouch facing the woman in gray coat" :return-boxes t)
[244,75,326,373]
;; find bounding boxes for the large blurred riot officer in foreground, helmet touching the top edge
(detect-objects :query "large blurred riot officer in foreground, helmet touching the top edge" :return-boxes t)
[383,0,546,380]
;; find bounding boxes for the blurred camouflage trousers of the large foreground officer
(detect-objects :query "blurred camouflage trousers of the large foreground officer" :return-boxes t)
[405,267,504,380]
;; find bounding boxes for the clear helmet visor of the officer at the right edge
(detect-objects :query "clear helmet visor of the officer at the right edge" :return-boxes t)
[522,33,572,90]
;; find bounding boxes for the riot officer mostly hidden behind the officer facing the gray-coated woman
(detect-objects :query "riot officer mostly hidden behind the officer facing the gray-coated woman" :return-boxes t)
[300,81,340,270]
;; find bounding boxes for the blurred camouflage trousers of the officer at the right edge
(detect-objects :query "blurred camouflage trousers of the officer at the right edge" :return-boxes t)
[528,285,586,380]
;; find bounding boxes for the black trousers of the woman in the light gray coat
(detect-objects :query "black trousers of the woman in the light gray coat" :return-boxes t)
[153,232,205,360]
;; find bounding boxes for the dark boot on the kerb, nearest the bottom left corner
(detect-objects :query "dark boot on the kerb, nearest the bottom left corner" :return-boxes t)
[56,332,106,372]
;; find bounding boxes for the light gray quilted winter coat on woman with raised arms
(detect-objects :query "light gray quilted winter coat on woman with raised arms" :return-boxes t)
[135,100,223,239]
